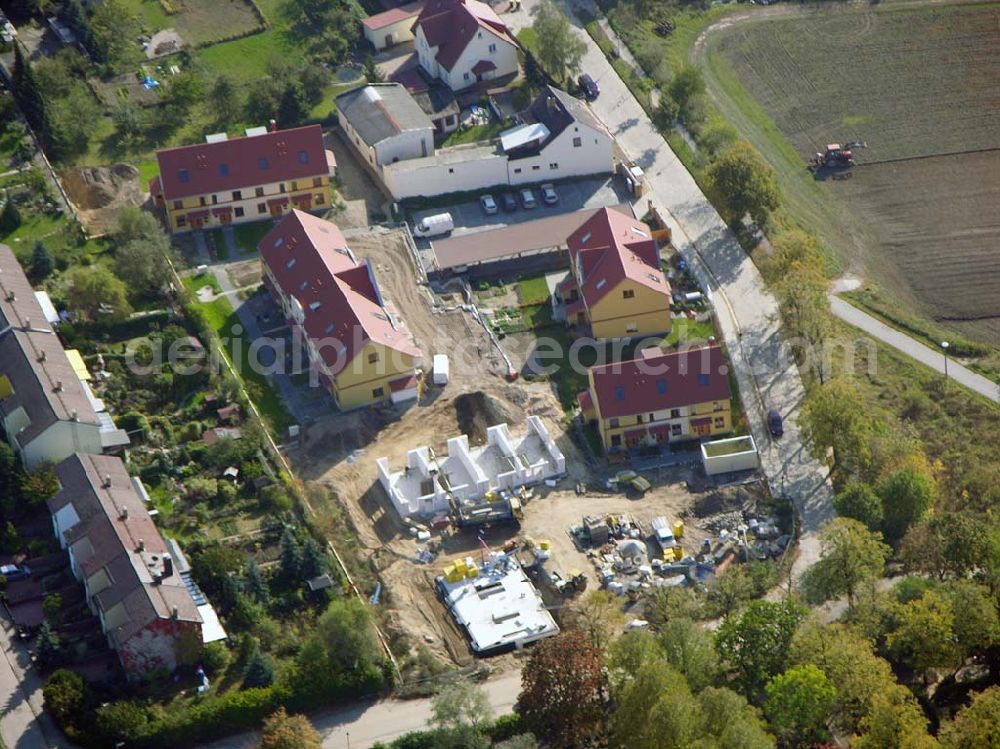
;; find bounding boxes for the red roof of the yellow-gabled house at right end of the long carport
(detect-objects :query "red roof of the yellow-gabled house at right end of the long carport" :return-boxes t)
[566,208,670,307]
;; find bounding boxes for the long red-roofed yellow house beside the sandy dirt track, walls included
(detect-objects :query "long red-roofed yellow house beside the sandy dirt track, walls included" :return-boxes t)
[258,210,422,411]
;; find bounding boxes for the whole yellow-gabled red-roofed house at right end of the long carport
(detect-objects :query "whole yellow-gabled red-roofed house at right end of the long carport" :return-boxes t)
[556,208,671,339]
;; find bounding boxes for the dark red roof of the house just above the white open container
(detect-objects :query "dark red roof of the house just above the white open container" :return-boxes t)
[591,346,730,419]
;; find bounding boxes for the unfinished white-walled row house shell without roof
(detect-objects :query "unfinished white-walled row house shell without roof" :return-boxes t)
[375,416,566,518]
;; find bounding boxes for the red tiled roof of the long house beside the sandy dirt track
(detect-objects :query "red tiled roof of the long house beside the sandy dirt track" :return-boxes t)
[258,209,420,374]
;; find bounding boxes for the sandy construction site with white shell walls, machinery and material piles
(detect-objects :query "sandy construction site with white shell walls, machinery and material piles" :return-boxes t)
[276,225,790,668]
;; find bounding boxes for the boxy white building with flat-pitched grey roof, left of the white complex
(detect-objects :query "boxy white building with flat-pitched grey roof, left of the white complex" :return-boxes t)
[336,83,434,172]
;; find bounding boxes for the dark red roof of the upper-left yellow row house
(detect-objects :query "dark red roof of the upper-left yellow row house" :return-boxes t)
[150,125,329,200]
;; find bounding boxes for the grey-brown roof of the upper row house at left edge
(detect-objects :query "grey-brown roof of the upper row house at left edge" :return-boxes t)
[0,244,101,447]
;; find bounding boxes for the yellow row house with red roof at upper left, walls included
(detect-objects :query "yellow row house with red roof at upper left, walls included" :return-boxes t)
[149,120,337,233]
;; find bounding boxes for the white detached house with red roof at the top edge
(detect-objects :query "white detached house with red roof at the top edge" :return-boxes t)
[413,0,518,91]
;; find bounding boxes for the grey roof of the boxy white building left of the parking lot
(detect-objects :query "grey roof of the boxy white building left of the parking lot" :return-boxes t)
[336,83,434,146]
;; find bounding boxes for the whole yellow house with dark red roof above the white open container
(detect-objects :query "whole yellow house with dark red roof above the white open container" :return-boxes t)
[577,345,733,453]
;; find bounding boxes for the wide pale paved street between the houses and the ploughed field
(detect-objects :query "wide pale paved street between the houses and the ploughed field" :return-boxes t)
[503,0,834,577]
